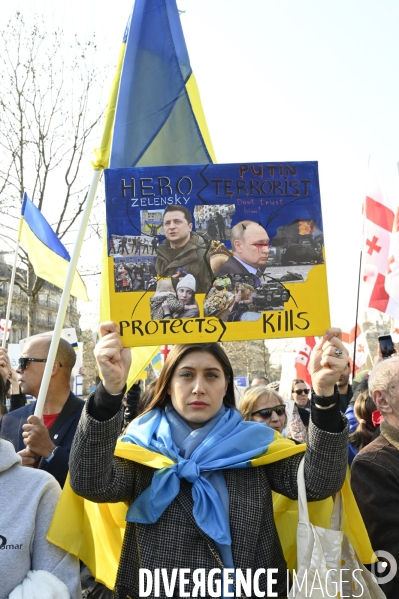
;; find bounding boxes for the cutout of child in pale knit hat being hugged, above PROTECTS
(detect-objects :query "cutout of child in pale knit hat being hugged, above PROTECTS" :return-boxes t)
[150,269,200,320]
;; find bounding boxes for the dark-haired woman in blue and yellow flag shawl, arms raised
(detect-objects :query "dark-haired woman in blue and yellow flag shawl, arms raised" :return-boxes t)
[70,322,348,599]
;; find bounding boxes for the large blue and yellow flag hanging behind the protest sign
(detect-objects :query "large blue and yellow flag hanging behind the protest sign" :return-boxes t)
[92,0,215,387]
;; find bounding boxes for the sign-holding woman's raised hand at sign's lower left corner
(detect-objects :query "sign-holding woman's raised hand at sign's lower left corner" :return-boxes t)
[94,321,132,395]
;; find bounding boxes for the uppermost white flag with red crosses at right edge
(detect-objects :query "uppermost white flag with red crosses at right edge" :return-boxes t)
[362,164,399,318]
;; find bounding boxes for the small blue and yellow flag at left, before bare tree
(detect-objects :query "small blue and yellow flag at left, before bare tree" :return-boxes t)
[18,193,89,302]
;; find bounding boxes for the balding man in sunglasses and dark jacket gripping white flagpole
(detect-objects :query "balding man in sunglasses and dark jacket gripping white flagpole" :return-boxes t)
[0,335,84,487]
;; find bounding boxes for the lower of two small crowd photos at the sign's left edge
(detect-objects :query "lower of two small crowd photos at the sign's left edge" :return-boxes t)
[114,256,157,293]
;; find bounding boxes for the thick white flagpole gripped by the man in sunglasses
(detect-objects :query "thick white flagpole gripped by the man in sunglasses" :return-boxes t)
[34,169,102,418]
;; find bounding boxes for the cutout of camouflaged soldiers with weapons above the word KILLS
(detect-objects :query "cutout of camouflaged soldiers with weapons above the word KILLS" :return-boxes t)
[204,273,290,322]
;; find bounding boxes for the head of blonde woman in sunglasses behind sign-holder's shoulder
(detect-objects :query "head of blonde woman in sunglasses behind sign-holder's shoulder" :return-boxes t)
[240,385,287,433]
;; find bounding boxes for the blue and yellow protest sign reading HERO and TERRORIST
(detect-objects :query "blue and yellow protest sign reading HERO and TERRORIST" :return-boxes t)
[105,162,330,346]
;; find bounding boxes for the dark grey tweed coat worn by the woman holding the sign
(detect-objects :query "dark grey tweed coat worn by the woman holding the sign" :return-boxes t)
[70,400,348,599]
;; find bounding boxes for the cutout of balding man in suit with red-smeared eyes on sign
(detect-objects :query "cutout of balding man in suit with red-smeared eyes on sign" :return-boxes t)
[214,220,270,277]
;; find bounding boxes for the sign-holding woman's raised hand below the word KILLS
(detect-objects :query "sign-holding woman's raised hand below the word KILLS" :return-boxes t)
[310,328,348,397]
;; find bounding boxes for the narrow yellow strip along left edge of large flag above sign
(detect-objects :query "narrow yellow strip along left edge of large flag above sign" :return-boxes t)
[91,42,126,171]
